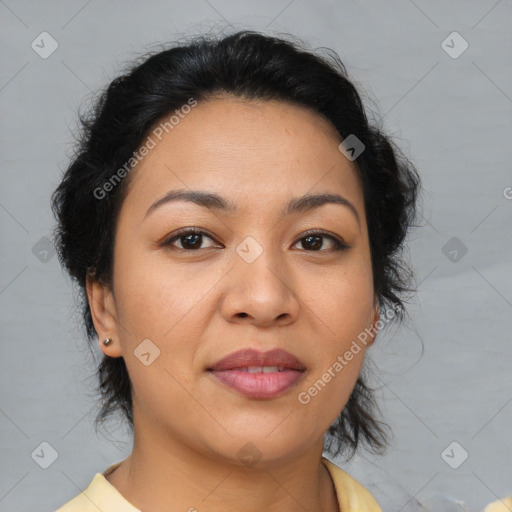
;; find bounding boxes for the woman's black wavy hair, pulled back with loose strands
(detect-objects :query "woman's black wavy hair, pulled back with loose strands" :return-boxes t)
[52,31,420,457]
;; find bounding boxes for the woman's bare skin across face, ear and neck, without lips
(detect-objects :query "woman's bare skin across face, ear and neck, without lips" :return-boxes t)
[87,96,378,512]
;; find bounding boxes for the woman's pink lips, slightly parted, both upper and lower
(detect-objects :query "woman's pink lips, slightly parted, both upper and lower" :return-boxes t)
[208,349,306,399]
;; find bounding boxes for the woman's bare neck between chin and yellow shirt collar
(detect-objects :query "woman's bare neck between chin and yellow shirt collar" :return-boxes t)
[106,412,339,512]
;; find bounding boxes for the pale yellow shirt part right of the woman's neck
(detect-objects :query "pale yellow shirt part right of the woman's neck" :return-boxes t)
[322,457,382,512]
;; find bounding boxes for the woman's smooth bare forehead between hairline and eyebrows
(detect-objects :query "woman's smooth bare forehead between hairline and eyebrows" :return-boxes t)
[121,96,362,215]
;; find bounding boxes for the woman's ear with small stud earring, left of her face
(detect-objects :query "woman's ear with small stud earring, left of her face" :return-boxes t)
[86,276,122,357]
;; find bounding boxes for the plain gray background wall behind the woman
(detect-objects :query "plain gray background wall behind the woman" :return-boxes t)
[0,0,512,511]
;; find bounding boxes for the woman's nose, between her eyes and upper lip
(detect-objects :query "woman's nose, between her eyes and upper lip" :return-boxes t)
[222,245,300,327]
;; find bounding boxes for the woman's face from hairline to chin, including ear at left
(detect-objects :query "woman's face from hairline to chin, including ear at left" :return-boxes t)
[90,97,378,462]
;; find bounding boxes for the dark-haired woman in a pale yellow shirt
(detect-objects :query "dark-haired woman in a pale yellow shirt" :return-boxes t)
[53,31,419,512]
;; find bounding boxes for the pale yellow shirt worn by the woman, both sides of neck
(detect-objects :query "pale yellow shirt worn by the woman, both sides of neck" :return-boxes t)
[56,457,382,512]
